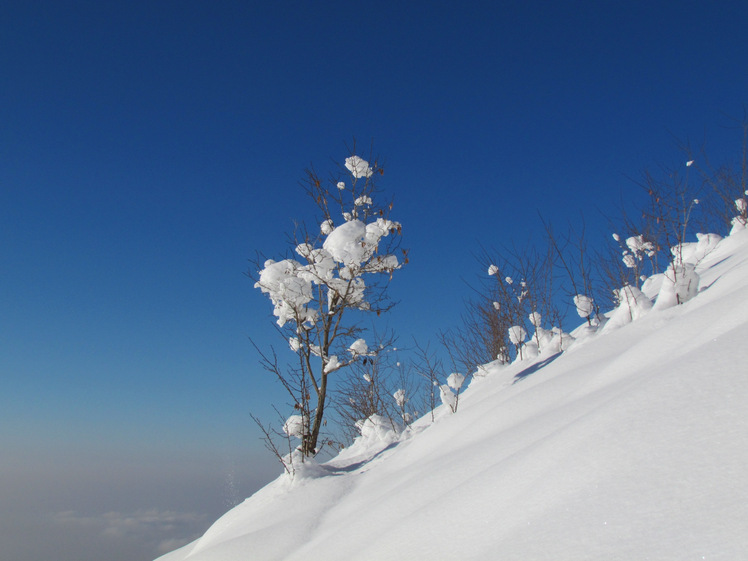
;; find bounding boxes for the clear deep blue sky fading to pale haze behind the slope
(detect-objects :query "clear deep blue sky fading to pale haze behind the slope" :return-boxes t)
[0,1,748,561]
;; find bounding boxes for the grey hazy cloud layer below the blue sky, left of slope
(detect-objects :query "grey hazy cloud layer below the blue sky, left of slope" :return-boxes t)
[0,446,279,561]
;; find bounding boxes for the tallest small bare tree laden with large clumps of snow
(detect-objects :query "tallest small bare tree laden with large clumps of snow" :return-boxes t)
[250,150,407,457]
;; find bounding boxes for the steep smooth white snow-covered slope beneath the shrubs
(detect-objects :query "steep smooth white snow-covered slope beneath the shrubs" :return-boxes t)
[161,230,748,561]
